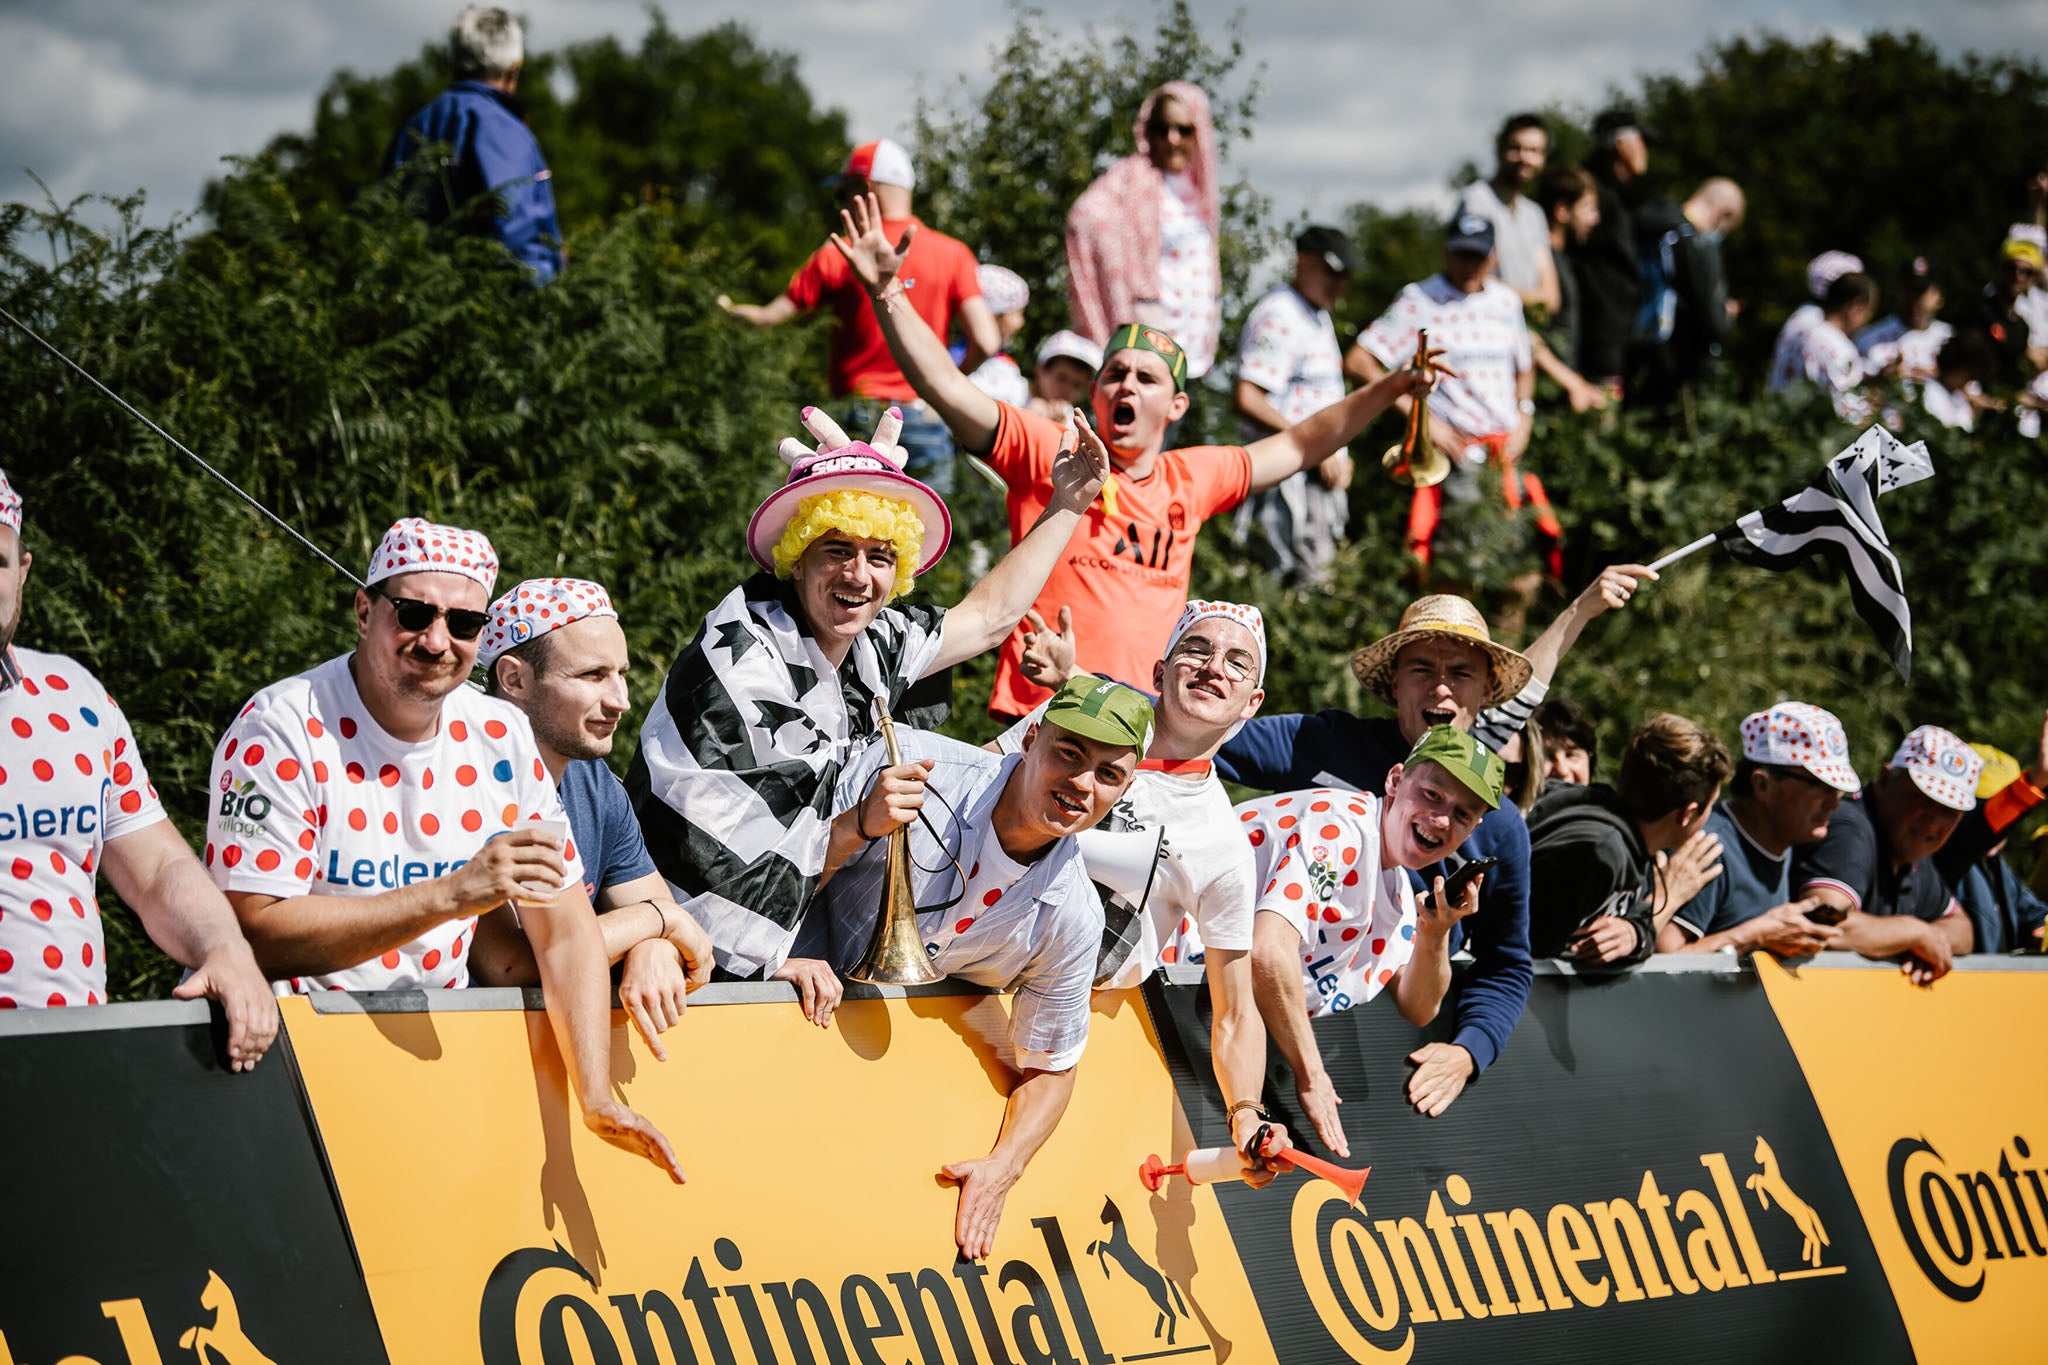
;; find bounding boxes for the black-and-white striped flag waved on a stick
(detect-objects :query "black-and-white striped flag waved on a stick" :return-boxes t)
[1716,426,1933,677]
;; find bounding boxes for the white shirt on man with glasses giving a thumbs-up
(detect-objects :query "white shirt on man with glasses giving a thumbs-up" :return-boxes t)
[995,702,1253,990]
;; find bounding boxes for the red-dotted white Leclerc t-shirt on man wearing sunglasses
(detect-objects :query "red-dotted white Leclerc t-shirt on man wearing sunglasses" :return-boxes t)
[205,655,584,993]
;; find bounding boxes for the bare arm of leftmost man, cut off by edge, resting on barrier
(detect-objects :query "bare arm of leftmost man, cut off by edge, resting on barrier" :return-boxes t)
[100,821,279,1070]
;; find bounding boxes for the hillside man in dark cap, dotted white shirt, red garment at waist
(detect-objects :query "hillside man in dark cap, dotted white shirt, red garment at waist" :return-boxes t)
[1343,213,1565,577]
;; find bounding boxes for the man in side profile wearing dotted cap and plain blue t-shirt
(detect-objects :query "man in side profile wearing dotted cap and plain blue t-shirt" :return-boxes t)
[469,579,711,1062]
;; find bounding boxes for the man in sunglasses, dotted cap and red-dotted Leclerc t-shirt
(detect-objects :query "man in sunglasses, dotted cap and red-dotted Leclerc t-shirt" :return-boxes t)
[207,518,682,1183]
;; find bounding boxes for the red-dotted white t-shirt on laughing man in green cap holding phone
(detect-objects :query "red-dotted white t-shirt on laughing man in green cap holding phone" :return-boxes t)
[1178,788,1415,1019]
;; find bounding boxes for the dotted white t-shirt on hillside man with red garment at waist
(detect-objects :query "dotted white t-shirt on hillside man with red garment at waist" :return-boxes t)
[1358,274,1532,436]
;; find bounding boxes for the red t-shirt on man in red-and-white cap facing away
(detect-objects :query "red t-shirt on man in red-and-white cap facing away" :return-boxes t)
[784,217,981,399]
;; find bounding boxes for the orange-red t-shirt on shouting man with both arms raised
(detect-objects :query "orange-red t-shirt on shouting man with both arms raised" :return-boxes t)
[989,403,1251,716]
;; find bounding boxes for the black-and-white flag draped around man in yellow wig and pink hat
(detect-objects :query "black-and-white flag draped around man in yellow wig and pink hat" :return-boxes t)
[627,573,944,976]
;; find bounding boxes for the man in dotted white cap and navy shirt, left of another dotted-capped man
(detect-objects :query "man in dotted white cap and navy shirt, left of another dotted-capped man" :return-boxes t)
[1657,702,1862,958]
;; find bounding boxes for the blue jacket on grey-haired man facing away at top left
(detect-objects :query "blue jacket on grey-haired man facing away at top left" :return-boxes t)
[385,80,561,284]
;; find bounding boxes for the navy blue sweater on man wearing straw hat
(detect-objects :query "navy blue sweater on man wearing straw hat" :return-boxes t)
[1217,710,1536,1070]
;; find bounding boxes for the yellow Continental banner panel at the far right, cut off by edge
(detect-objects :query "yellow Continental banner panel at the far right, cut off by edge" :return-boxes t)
[1757,954,2048,1365]
